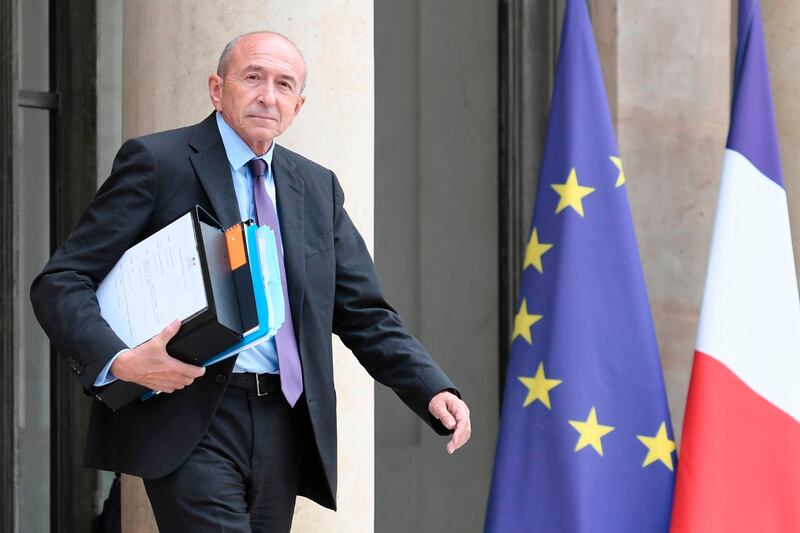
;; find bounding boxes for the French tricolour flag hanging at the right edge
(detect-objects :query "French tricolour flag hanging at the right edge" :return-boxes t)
[671,0,800,533]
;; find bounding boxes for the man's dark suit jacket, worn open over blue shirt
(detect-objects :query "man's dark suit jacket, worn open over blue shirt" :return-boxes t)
[31,113,454,508]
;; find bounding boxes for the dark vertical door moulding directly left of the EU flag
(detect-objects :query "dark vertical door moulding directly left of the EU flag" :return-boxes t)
[498,0,565,398]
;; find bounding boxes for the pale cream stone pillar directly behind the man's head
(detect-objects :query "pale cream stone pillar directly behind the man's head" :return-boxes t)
[122,0,374,533]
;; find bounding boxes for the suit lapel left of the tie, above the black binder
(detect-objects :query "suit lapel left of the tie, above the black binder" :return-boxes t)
[189,113,240,228]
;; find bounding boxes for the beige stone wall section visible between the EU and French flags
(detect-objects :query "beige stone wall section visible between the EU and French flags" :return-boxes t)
[591,0,732,439]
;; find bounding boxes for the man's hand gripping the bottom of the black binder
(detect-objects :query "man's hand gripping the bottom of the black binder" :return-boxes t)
[110,320,206,392]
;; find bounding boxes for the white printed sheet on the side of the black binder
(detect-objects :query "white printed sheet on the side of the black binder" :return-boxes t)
[97,213,208,348]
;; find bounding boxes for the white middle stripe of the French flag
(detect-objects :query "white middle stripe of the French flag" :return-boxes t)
[697,149,800,421]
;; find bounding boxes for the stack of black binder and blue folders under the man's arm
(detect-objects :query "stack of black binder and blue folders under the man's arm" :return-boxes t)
[94,206,286,409]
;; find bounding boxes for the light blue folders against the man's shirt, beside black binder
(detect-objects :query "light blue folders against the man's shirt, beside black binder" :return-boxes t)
[140,223,286,400]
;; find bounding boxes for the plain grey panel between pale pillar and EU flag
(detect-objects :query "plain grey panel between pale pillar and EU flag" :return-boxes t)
[375,0,499,533]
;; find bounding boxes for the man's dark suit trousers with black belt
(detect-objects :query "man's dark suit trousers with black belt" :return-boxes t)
[144,386,305,533]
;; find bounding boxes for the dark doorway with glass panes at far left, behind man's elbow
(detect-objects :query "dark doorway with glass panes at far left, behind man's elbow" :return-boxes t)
[0,0,97,532]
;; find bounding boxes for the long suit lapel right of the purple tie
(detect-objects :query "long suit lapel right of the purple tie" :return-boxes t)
[272,146,306,340]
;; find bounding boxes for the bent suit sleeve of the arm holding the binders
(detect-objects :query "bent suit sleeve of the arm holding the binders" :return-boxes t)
[31,139,157,390]
